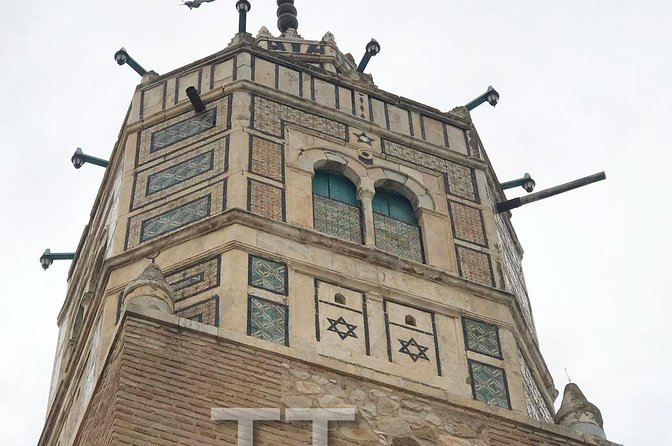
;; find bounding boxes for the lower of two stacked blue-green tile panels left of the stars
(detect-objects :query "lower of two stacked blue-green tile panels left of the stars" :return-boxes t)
[247,296,288,345]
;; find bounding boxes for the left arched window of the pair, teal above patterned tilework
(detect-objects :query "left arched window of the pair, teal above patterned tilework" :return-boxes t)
[313,171,362,243]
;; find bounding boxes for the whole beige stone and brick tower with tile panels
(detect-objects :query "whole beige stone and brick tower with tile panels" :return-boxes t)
[39,8,611,446]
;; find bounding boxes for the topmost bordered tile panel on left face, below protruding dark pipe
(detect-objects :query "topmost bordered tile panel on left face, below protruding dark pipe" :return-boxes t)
[137,95,231,165]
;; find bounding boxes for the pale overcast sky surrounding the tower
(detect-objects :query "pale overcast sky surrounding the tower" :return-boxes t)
[0,0,672,446]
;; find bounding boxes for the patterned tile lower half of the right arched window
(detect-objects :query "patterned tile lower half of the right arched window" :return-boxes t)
[373,213,424,263]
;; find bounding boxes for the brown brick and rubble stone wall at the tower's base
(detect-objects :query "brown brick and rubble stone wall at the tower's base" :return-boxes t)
[75,317,608,446]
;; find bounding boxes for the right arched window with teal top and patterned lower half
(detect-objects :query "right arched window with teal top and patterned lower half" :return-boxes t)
[373,189,424,263]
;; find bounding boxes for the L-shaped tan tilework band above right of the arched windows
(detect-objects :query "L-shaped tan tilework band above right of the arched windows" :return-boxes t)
[383,140,479,202]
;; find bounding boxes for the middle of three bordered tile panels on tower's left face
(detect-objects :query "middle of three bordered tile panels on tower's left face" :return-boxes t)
[131,137,228,210]
